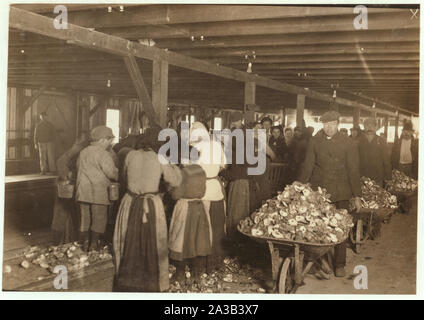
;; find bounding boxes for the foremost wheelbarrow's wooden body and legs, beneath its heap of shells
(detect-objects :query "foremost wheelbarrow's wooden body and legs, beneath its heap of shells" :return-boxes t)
[237,227,347,293]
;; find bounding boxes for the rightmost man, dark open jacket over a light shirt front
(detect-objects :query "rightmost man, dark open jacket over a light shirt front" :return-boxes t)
[392,121,418,179]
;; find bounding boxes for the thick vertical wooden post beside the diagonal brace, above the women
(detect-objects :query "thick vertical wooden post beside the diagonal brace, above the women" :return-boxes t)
[152,60,169,128]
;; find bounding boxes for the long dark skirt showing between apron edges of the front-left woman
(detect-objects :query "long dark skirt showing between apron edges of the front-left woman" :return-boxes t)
[114,198,168,292]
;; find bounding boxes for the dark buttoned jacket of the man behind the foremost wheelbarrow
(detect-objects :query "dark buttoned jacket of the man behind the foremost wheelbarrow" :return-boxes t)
[298,132,361,202]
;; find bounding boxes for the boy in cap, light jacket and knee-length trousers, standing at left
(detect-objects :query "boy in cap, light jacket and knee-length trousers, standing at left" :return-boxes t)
[76,126,118,251]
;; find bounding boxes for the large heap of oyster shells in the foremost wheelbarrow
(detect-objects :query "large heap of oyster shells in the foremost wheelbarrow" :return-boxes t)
[239,181,353,244]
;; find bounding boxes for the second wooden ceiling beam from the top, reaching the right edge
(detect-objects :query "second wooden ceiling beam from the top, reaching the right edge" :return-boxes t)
[102,9,420,41]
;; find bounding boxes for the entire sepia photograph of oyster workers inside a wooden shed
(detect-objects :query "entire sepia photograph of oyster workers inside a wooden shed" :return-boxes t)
[0,1,422,296]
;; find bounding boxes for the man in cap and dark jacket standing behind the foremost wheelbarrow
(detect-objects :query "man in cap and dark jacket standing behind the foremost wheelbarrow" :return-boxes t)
[299,111,361,277]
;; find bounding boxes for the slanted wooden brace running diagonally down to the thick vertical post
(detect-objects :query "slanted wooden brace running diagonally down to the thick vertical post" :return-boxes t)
[124,55,158,124]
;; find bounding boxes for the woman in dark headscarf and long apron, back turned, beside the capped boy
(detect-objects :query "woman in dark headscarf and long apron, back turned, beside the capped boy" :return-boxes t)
[113,127,181,292]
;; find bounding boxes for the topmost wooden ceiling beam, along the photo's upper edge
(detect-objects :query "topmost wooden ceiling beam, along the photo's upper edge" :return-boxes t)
[28,4,410,28]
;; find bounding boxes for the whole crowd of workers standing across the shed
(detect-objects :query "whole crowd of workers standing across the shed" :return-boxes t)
[48,111,418,292]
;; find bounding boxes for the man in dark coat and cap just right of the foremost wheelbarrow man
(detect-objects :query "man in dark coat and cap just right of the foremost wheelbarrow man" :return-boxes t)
[358,118,392,186]
